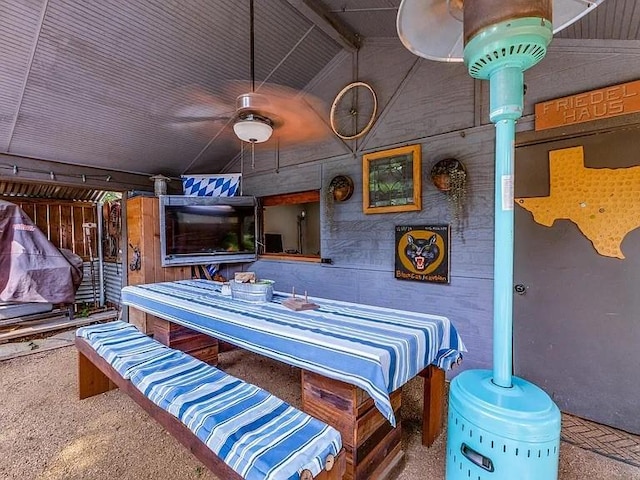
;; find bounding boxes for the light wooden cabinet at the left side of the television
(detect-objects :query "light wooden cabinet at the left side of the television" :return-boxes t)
[127,197,191,333]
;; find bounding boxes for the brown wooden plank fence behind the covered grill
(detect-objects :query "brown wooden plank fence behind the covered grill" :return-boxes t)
[10,197,98,261]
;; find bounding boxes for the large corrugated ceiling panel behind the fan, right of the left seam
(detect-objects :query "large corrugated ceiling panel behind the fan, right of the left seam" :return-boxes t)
[5,0,339,175]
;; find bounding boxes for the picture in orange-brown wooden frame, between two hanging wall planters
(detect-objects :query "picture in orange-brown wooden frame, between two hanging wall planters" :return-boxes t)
[362,145,422,214]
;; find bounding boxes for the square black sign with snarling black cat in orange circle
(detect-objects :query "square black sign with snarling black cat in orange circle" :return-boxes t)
[395,225,451,283]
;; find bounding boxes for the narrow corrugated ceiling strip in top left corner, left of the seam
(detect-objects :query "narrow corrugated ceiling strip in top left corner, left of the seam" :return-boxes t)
[0,0,44,152]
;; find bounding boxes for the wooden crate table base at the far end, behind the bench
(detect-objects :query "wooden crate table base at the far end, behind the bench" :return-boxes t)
[153,318,218,365]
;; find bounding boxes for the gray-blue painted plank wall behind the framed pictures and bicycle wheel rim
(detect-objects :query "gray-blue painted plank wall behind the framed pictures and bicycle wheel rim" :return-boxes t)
[228,39,640,374]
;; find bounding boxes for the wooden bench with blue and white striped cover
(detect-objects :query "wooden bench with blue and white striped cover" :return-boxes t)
[76,322,346,480]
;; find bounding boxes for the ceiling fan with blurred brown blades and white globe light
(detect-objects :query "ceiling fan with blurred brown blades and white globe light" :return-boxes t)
[159,0,329,151]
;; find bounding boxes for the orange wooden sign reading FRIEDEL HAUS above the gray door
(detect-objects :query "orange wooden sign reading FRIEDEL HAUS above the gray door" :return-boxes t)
[536,80,640,131]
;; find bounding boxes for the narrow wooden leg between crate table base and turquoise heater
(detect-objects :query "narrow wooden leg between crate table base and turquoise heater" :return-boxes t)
[418,365,444,447]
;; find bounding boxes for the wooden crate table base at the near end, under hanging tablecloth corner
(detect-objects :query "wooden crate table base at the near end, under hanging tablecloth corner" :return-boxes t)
[302,370,404,480]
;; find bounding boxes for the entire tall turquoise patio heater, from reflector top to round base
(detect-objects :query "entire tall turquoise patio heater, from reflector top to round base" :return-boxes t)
[397,0,602,480]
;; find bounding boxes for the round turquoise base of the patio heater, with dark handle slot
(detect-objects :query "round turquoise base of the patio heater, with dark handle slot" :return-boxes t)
[446,370,560,480]
